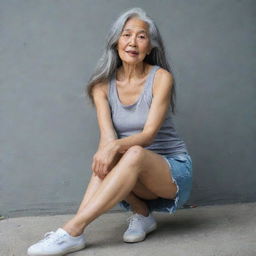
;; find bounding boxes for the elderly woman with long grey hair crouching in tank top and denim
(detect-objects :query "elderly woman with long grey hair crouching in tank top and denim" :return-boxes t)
[28,8,192,255]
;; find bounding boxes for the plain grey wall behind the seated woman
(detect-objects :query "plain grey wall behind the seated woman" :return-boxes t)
[0,0,256,217]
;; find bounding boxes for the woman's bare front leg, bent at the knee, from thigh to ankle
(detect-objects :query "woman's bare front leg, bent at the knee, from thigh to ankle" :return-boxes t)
[63,146,177,236]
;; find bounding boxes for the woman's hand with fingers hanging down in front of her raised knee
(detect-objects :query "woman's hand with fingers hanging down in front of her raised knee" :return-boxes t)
[92,141,120,179]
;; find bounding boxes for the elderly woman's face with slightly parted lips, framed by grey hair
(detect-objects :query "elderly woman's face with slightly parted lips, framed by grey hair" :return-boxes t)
[117,17,151,64]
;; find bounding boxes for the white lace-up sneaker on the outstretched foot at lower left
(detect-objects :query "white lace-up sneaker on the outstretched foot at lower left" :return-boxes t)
[27,228,85,256]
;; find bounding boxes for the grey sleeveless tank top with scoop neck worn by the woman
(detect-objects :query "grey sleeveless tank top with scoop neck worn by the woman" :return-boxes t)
[108,65,188,156]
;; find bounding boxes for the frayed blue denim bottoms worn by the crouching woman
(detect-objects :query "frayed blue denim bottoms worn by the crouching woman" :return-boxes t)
[119,153,192,214]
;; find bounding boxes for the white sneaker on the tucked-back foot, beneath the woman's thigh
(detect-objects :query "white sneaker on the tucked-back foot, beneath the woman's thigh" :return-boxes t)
[123,213,157,243]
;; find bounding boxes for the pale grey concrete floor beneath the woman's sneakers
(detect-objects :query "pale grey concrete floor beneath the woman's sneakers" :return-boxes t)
[0,203,256,256]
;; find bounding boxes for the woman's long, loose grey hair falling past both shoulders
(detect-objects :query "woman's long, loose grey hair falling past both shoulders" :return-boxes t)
[86,7,176,114]
